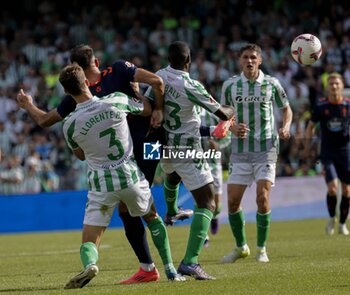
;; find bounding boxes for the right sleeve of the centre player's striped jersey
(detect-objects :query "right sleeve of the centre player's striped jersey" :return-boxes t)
[185,80,220,113]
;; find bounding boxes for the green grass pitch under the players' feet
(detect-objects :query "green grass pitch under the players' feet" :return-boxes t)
[0,220,350,295]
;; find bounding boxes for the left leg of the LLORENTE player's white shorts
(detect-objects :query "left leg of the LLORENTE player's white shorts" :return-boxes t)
[84,191,120,227]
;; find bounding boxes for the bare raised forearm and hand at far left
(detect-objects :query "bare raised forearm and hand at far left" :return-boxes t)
[17,89,62,128]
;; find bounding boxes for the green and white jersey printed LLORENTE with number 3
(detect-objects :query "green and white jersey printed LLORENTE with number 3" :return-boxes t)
[63,92,143,192]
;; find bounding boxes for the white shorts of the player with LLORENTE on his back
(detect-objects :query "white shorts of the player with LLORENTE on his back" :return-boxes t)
[84,179,153,227]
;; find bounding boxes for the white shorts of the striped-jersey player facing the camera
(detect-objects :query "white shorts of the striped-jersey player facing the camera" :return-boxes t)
[227,149,277,186]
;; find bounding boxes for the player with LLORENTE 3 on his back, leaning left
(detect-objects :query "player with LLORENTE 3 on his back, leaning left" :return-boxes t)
[54,63,184,289]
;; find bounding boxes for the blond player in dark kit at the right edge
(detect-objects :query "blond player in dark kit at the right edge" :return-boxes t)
[304,73,350,235]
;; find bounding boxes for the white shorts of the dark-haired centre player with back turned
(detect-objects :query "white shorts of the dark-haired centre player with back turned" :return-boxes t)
[161,159,213,191]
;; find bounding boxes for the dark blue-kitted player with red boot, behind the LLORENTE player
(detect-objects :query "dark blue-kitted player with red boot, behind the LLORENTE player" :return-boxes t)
[17,45,172,284]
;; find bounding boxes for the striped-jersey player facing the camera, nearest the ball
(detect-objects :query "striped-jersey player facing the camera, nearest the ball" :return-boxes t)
[221,44,293,263]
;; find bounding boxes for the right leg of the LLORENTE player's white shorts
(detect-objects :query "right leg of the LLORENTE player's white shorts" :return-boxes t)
[118,179,153,216]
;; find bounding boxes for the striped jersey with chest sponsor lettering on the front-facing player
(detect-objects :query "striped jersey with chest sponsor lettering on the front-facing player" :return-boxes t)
[221,71,289,153]
